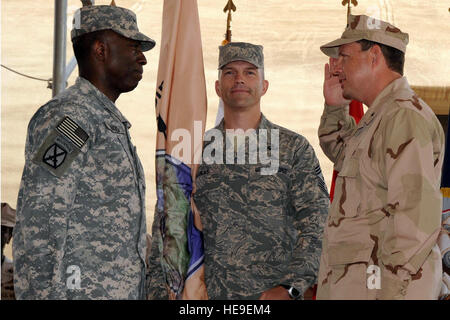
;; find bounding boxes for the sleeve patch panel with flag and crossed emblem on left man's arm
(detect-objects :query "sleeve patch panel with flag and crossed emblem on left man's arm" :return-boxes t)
[33,117,89,177]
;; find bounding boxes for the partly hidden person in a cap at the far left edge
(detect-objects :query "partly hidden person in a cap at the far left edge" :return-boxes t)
[1,202,16,300]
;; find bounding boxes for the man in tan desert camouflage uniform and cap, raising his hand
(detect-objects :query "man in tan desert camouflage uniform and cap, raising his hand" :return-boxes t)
[317,15,444,299]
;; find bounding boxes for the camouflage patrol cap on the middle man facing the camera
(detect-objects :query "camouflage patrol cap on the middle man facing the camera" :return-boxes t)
[219,42,264,69]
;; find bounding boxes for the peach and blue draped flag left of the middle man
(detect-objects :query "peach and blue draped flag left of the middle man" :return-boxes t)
[153,0,207,299]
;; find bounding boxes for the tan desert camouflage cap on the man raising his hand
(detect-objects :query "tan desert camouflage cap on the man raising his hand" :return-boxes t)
[320,15,409,58]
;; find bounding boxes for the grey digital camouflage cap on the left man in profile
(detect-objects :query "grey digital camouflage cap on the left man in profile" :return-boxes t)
[70,5,155,51]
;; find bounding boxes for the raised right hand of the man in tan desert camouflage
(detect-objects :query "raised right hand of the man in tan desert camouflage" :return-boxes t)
[323,57,350,106]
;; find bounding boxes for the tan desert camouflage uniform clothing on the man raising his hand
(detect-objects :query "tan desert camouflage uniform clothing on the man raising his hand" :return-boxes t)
[317,77,445,299]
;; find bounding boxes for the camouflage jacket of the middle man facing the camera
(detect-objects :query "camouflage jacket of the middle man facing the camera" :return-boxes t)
[194,115,329,299]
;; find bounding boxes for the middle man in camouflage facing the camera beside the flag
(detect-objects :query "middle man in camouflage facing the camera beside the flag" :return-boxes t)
[150,42,329,299]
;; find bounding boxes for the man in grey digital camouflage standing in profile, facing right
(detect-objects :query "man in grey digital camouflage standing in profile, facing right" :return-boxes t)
[13,6,155,299]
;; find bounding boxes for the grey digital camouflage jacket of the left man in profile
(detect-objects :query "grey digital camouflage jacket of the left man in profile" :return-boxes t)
[13,77,146,299]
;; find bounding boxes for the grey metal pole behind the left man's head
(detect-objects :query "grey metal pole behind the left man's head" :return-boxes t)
[52,0,67,97]
